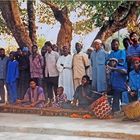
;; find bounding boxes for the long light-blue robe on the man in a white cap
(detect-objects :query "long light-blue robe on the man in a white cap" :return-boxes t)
[91,49,108,92]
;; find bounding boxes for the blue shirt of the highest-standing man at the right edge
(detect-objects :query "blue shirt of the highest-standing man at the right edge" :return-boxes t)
[127,44,140,57]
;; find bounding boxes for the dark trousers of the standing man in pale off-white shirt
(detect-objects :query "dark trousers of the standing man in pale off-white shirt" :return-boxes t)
[46,76,58,99]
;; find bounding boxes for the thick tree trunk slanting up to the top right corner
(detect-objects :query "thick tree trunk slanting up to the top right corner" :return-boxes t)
[92,1,139,45]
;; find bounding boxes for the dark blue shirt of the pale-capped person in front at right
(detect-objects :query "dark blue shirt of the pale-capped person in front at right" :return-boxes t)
[110,66,127,90]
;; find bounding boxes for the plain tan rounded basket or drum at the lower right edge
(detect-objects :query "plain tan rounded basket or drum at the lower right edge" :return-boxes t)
[122,101,140,119]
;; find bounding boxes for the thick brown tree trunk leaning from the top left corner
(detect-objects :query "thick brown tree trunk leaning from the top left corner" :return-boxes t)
[0,0,32,49]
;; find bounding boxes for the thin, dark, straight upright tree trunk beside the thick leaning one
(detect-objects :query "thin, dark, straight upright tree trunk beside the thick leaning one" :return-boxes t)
[27,0,37,44]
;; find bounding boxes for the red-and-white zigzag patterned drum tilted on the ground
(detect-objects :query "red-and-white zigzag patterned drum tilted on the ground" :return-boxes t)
[90,96,112,119]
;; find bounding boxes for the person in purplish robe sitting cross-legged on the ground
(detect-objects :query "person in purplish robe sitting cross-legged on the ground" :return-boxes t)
[17,79,45,108]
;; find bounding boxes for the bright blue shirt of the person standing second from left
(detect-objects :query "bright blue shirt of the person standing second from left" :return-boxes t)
[6,60,19,84]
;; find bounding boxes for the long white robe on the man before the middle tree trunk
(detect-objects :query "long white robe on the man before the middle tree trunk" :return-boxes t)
[56,55,74,100]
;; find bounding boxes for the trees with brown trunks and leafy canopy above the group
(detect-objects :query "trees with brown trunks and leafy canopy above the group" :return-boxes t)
[0,0,140,48]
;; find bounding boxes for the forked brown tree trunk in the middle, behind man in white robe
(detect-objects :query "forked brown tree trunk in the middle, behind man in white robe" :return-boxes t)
[41,0,72,48]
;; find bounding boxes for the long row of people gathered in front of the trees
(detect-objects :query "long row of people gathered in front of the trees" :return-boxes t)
[0,32,140,115]
